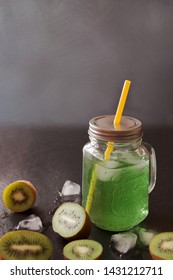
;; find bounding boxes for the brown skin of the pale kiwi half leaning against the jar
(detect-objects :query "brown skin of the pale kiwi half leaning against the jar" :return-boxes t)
[52,202,92,241]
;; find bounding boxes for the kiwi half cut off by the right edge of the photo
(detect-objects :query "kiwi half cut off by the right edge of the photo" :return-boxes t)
[149,232,173,260]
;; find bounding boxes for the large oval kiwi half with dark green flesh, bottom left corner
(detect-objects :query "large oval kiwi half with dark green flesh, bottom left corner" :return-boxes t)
[0,230,53,260]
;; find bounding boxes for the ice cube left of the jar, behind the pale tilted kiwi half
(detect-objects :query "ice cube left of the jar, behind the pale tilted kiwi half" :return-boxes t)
[59,180,81,203]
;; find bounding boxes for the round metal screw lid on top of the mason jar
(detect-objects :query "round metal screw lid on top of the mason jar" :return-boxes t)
[88,115,143,142]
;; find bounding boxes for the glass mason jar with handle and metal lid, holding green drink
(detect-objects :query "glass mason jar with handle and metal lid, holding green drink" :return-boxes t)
[82,115,156,231]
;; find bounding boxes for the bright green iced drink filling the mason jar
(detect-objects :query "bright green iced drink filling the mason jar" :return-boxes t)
[82,150,149,231]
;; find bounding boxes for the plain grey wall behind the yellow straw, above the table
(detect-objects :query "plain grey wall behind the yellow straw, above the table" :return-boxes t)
[0,0,173,126]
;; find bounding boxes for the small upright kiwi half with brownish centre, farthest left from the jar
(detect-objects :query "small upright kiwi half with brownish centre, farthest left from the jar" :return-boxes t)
[3,180,36,212]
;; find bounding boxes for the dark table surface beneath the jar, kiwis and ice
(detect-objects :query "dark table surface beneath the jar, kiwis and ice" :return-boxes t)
[0,126,173,260]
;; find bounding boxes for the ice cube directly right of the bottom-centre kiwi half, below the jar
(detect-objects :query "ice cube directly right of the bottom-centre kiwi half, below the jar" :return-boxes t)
[111,232,137,254]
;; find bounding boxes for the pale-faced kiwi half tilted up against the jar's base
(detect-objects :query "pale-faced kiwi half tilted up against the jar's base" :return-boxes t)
[52,202,91,241]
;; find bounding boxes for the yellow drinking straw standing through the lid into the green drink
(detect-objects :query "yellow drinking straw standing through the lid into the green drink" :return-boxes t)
[85,80,131,214]
